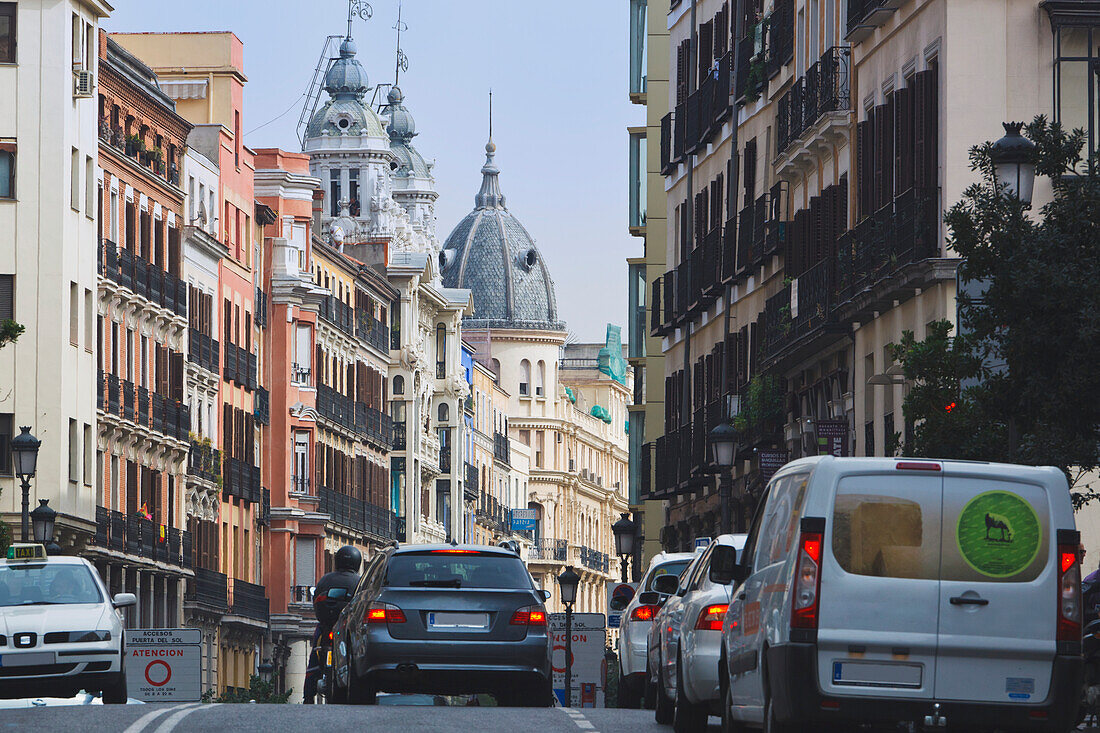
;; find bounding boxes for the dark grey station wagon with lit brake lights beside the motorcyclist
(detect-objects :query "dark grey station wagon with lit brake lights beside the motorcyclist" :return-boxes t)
[323,545,553,707]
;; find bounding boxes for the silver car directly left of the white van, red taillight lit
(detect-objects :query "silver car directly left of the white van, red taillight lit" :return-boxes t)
[655,535,746,733]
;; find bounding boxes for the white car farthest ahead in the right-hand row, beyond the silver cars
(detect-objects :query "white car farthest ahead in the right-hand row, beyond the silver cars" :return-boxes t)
[618,553,695,708]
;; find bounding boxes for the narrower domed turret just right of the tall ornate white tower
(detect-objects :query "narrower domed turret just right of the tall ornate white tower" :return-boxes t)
[386,86,439,241]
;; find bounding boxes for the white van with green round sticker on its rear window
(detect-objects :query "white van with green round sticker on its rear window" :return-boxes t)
[719,457,1081,731]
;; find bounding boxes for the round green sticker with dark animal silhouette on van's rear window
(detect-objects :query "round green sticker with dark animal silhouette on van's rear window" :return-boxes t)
[955,491,1043,578]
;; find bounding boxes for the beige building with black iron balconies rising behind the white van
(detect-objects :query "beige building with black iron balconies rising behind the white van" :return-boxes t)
[650,0,1082,548]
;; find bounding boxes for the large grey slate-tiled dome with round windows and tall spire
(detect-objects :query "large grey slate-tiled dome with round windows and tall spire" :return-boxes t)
[440,140,565,331]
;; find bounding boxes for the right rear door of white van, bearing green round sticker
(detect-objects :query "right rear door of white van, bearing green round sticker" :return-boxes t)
[936,473,1058,703]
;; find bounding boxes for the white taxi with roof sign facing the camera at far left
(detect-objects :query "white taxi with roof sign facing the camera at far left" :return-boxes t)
[0,544,138,703]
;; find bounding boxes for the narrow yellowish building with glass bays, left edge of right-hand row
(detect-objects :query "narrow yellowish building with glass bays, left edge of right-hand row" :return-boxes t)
[627,0,670,563]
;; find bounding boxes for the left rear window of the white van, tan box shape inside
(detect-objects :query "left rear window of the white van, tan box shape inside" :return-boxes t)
[833,483,939,578]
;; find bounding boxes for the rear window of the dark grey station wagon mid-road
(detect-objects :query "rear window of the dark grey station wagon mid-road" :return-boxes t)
[383,550,534,590]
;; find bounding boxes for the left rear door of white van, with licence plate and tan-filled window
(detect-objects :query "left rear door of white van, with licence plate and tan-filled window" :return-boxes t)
[817,462,946,699]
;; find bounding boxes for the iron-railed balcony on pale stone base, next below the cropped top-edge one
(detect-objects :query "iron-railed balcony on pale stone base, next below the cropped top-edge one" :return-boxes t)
[776,46,851,166]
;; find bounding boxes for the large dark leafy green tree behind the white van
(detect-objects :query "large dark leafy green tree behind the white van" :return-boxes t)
[895,117,1100,503]
